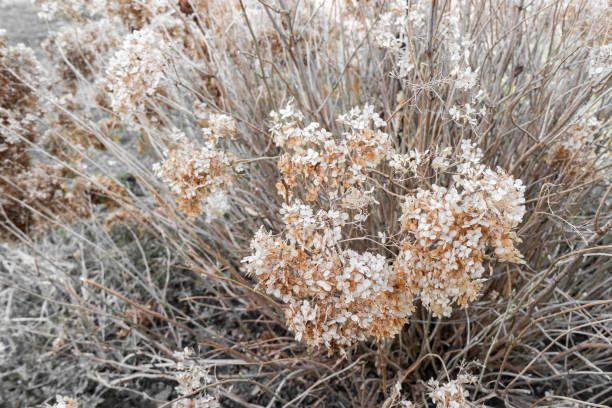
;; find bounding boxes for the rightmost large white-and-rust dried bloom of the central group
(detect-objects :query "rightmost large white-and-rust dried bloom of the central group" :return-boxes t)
[395,141,525,317]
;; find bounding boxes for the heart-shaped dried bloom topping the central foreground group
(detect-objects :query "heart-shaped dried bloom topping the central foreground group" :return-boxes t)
[270,105,390,201]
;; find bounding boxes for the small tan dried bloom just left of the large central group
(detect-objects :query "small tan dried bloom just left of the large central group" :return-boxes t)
[154,133,233,217]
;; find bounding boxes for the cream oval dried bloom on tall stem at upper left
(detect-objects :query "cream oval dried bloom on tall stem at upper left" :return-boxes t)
[106,27,168,124]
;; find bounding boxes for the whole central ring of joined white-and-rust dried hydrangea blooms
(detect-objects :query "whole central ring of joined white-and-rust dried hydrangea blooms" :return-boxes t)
[244,106,525,349]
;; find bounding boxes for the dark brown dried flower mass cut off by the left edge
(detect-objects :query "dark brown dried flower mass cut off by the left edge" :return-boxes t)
[0,40,66,240]
